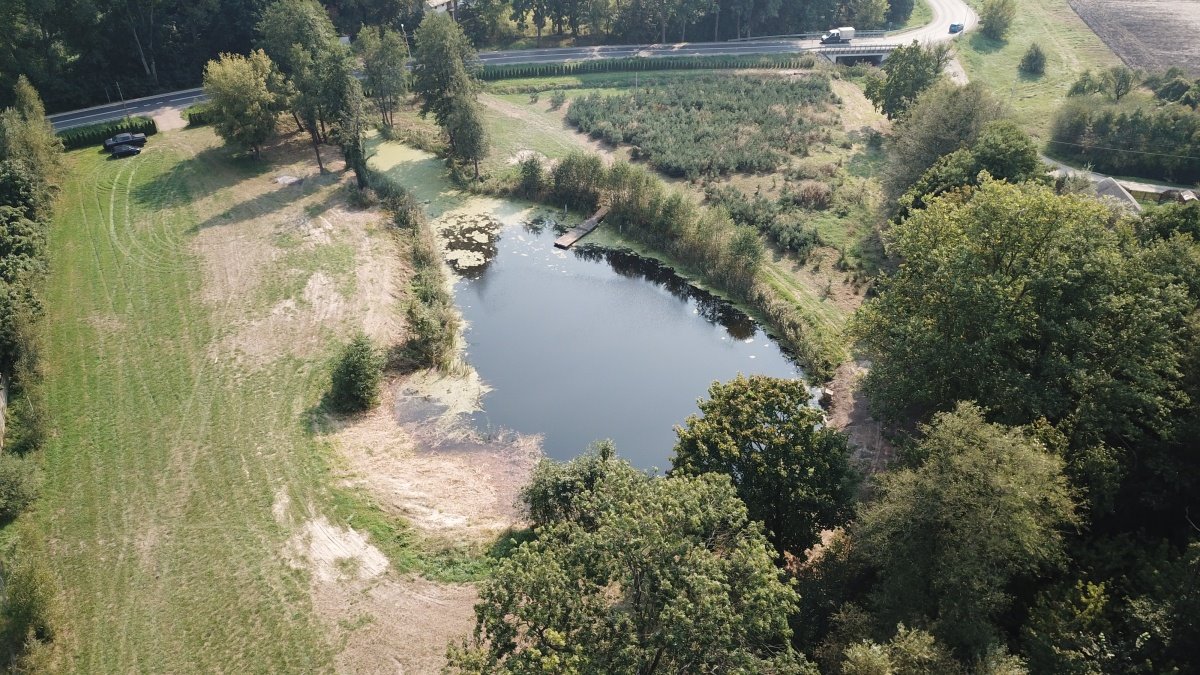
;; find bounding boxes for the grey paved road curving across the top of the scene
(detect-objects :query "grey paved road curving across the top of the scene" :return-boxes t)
[48,0,979,131]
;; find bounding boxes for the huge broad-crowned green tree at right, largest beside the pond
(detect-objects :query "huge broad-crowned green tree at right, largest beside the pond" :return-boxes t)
[852,180,1190,448]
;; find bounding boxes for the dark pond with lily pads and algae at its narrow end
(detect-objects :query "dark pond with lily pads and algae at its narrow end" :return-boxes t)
[373,144,800,470]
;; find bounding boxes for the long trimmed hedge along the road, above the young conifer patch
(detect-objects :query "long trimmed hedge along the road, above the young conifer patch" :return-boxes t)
[480,54,817,80]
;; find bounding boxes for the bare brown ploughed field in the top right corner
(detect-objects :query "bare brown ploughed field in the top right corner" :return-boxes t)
[1069,0,1200,77]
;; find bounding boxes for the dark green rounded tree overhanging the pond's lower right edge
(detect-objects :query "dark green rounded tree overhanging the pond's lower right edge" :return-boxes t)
[671,375,857,554]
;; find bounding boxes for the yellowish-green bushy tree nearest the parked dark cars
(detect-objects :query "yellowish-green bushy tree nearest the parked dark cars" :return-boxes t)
[204,49,280,156]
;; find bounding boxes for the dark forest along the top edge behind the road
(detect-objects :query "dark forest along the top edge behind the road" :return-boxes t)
[0,0,912,113]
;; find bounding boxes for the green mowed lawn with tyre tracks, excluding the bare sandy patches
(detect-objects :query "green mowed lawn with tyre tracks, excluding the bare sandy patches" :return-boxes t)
[36,130,379,673]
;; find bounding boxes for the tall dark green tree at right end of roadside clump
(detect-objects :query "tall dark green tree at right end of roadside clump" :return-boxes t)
[413,12,479,127]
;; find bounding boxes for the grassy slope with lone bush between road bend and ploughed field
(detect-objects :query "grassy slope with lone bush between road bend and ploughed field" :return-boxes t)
[955,0,1121,141]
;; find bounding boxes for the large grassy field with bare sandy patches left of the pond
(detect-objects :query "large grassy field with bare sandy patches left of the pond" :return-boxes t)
[32,129,511,673]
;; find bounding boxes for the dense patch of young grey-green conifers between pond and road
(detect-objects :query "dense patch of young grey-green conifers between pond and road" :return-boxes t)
[566,74,832,178]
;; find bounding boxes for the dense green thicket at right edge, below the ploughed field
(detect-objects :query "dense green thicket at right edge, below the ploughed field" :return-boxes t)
[1050,97,1200,183]
